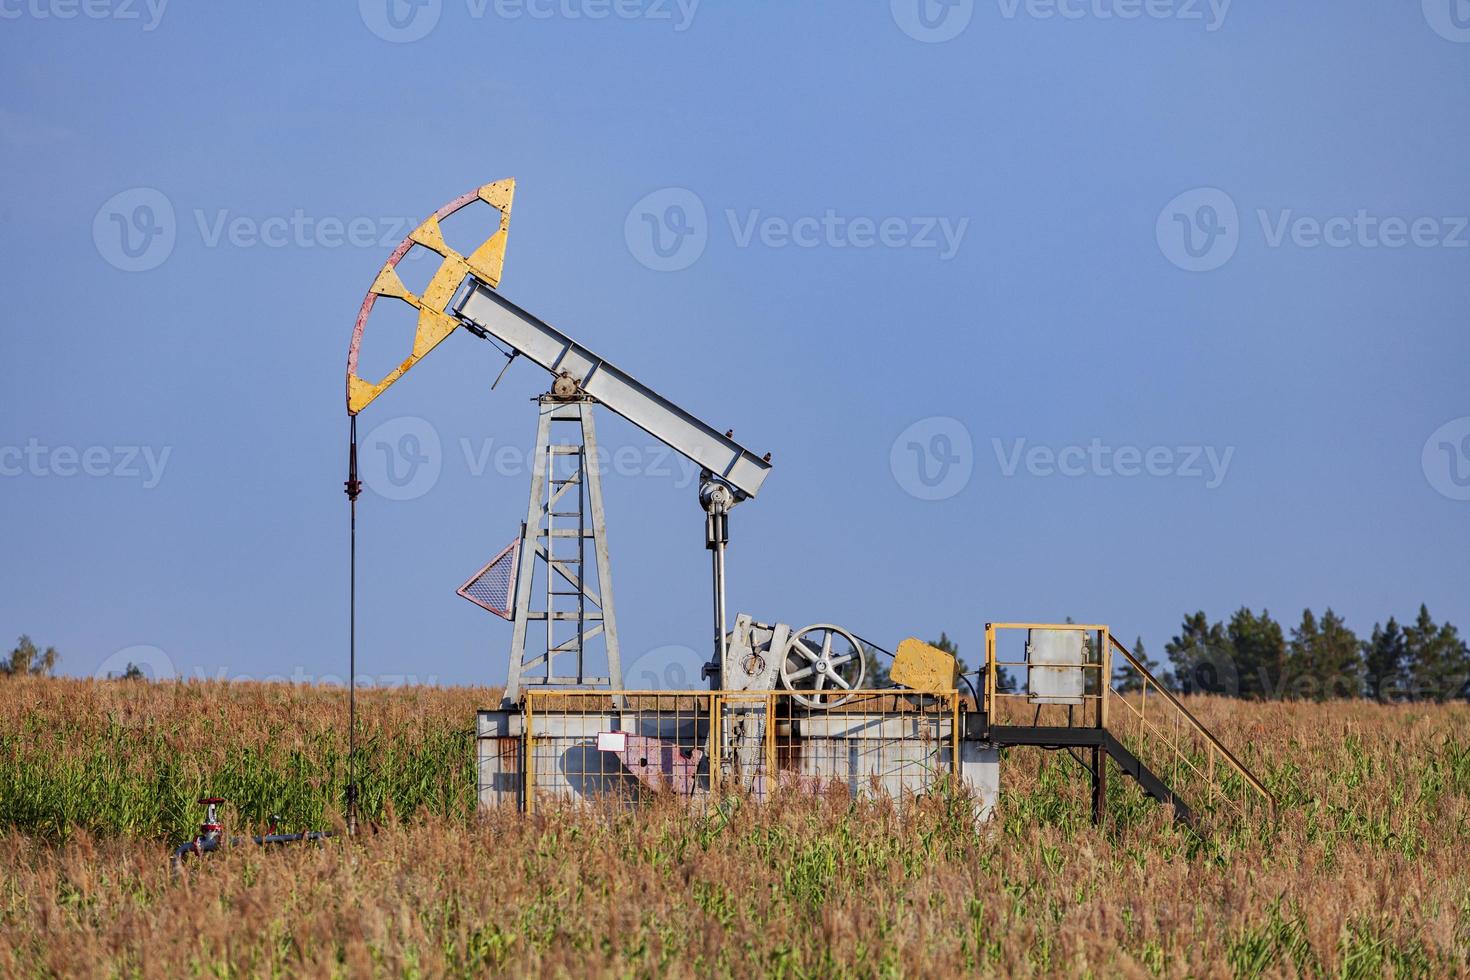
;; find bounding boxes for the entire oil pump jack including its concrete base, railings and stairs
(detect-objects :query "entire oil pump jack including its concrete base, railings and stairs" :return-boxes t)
[345,179,1274,830]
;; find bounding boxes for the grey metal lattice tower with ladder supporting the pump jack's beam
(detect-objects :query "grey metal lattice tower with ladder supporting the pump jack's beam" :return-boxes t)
[506,395,623,704]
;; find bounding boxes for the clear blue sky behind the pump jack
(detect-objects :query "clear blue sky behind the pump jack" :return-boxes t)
[0,0,1470,683]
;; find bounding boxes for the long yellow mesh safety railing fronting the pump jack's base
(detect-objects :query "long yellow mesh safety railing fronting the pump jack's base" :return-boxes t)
[520,691,963,811]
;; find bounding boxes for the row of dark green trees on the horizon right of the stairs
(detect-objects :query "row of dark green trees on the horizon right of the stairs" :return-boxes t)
[1114,605,1470,702]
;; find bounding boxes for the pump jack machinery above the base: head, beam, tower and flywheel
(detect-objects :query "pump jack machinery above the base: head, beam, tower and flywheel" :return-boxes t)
[347,179,864,707]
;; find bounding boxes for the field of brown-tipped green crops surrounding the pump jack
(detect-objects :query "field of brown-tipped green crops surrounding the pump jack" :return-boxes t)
[0,679,1470,977]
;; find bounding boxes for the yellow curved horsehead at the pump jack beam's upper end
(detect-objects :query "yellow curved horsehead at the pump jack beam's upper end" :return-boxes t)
[347,178,516,414]
